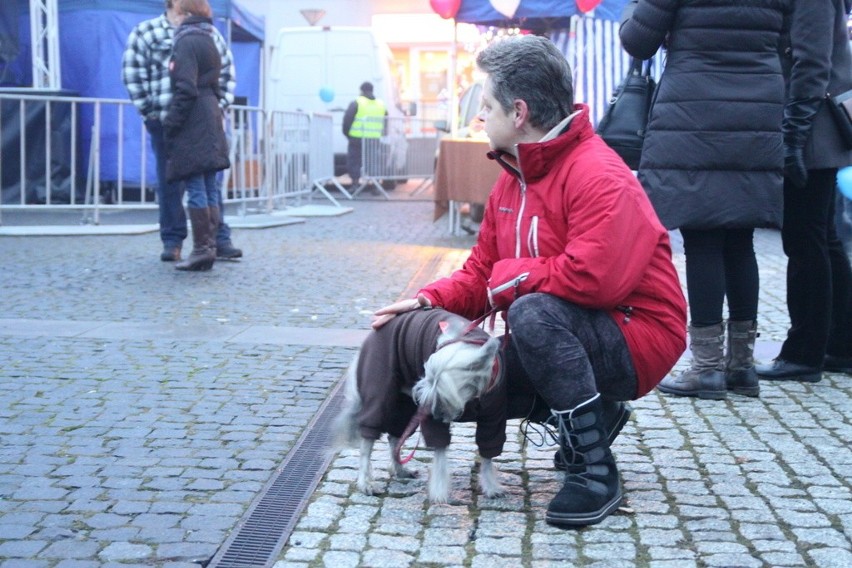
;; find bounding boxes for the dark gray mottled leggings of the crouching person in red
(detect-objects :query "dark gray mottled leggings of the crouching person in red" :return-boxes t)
[504,293,638,410]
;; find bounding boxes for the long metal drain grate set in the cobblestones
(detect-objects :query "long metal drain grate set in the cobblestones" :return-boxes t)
[208,380,343,568]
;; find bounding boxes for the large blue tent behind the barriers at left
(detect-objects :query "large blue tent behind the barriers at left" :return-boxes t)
[0,0,264,184]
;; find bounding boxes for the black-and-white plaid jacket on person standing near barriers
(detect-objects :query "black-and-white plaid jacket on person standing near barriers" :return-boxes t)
[121,13,236,120]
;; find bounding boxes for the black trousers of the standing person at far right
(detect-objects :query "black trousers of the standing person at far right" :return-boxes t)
[779,168,852,367]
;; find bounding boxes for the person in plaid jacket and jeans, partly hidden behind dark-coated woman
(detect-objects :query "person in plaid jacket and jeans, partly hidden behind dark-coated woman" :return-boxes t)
[122,0,243,261]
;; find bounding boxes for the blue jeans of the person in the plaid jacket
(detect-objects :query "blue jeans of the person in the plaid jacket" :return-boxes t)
[145,120,231,248]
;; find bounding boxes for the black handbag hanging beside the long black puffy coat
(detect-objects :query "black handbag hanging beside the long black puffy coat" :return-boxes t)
[597,58,657,170]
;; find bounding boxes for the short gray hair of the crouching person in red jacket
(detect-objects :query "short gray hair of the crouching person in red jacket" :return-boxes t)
[476,35,574,130]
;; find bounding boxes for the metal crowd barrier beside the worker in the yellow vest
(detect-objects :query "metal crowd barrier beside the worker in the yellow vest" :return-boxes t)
[352,117,438,198]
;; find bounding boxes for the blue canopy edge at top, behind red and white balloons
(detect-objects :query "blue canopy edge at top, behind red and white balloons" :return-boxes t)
[455,0,627,32]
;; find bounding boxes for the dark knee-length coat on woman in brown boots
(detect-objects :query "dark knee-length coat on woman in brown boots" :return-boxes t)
[163,16,230,181]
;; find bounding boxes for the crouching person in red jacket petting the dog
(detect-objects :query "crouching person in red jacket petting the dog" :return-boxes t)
[373,36,686,526]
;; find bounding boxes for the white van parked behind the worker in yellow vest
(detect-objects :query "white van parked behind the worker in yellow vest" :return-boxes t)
[266,26,403,175]
